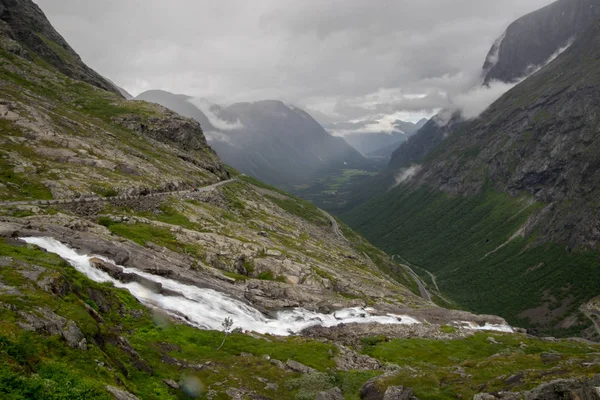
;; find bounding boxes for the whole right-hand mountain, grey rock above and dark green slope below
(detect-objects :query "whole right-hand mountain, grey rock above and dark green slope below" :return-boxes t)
[345,19,600,337]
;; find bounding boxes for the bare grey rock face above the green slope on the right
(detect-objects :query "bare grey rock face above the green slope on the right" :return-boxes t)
[418,21,600,248]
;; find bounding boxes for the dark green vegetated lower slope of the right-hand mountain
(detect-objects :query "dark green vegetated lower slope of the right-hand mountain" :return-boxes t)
[344,186,600,335]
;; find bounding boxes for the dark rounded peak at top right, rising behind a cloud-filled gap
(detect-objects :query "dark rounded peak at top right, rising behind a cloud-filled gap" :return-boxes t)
[483,0,600,83]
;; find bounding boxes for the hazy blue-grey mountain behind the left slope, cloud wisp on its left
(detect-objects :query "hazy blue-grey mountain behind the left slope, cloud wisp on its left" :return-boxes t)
[137,91,369,188]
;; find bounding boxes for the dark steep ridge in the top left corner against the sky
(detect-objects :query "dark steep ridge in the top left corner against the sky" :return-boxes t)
[0,0,120,94]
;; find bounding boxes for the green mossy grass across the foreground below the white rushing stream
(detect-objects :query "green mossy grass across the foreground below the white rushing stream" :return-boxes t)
[0,238,600,400]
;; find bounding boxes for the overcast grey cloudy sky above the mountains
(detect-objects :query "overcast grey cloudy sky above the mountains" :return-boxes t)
[36,0,552,127]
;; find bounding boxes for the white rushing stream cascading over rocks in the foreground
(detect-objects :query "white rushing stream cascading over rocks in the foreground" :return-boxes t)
[21,237,420,336]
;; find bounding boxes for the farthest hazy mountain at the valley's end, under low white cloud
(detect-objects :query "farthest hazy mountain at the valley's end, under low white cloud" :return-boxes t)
[327,119,427,157]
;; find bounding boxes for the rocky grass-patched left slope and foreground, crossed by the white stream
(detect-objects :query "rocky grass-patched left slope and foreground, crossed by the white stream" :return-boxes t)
[0,1,600,400]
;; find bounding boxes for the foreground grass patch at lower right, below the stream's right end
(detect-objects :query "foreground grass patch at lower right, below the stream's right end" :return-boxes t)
[365,333,594,400]
